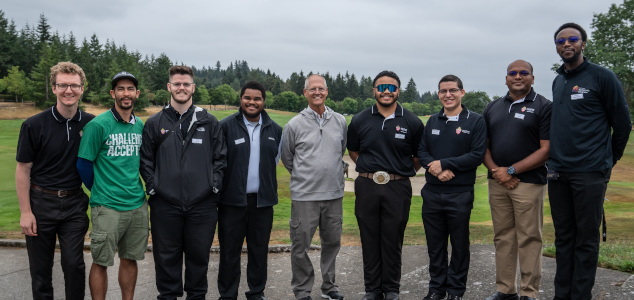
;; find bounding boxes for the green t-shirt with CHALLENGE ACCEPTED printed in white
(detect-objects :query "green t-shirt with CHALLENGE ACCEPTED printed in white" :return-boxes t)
[77,110,145,211]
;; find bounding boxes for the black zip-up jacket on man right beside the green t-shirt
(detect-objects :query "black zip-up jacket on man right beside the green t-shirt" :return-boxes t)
[141,105,227,211]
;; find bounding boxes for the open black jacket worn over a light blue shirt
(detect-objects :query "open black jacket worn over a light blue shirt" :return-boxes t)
[220,110,282,207]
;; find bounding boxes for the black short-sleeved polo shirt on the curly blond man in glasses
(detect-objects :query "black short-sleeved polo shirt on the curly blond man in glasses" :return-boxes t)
[16,106,95,190]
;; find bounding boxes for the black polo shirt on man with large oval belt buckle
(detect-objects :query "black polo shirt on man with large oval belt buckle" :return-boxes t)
[348,104,425,177]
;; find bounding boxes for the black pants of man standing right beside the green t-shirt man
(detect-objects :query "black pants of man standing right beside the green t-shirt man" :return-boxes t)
[149,196,218,299]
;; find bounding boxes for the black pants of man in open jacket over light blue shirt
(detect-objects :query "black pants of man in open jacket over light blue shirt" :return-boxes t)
[218,194,273,299]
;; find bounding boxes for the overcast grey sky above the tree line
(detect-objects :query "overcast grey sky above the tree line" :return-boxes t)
[0,0,623,99]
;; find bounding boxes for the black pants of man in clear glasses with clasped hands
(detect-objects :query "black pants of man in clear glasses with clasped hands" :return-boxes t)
[421,188,473,296]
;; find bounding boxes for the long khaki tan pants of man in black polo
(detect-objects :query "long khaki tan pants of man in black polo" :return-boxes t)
[489,179,546,298]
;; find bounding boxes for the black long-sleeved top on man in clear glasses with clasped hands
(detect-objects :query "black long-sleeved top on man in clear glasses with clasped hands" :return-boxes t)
[418,105,487,194]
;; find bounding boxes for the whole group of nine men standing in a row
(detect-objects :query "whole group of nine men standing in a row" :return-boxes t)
[16,23,631,300]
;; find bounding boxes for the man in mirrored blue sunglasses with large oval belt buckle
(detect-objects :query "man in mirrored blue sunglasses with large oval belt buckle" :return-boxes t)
[348,71,424,300]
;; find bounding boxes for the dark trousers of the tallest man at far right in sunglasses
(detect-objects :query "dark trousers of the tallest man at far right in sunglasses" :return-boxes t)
[548,169,612,300]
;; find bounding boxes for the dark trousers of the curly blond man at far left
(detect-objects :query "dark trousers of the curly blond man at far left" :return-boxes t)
[26,188,89,300]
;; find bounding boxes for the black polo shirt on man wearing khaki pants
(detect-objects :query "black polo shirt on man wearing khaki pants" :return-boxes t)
[482,88,552,184]
